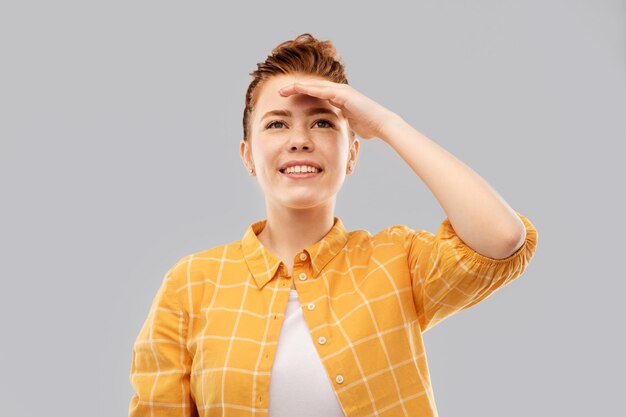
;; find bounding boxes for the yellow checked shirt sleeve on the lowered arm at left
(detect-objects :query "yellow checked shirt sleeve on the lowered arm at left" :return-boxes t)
[128,263,198,417]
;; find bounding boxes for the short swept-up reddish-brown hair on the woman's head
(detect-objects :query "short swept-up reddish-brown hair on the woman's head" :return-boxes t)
[243,33,355,141]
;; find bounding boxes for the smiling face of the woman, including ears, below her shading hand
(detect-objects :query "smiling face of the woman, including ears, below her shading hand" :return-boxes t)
[240,74,359,209]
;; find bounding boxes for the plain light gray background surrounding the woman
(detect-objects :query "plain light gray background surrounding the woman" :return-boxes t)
[0,0,626,417]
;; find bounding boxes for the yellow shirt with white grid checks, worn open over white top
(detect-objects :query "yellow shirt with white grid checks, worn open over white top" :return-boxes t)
[129,213,537,417]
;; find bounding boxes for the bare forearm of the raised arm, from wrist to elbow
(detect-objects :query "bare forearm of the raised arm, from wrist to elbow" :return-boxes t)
[380,116,526,259]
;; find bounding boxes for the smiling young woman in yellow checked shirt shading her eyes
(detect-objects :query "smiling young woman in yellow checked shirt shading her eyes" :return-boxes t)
[129,34,537,417]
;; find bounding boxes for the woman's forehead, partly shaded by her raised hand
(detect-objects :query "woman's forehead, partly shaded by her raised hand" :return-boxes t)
[255,74,332,111]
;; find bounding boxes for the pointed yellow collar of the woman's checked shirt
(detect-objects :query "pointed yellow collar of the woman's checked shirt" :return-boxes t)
[241,216,348,288]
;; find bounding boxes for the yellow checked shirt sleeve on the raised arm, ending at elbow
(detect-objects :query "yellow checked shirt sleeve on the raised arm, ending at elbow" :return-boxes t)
[392,212,537,332]
